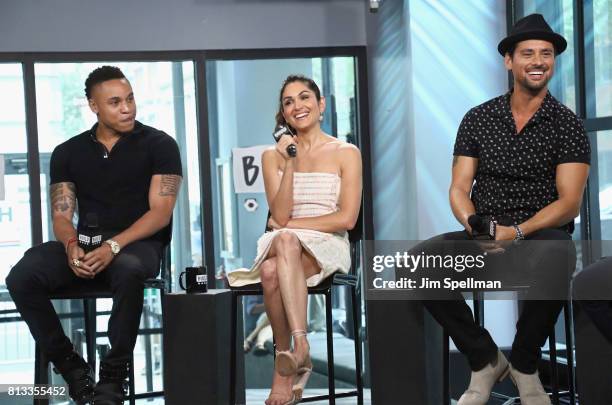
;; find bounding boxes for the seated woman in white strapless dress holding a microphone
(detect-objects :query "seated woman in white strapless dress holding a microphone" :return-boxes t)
[228,76,361,405]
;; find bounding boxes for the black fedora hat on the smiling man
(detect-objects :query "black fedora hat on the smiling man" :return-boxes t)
[497,14,567,56]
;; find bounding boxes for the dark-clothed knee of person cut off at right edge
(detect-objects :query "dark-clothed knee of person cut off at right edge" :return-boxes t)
[573,257,612,343]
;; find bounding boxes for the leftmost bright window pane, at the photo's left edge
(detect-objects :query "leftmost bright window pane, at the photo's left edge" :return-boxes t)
[0,63,34,384]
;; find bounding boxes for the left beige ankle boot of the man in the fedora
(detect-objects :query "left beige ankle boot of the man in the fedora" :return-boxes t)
[457,350,509,405]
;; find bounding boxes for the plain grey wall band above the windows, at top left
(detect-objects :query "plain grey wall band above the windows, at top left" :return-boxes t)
[0,0,367,52]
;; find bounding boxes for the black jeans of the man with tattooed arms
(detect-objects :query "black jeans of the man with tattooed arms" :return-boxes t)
[6,241,162,366]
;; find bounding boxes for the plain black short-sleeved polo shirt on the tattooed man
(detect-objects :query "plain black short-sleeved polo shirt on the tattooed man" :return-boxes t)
[51,121,182,243]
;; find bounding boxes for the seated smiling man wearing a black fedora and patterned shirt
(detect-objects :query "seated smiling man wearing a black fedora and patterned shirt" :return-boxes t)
[424,14,590,405]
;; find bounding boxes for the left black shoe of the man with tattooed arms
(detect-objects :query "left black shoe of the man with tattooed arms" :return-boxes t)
[53,352,95,405]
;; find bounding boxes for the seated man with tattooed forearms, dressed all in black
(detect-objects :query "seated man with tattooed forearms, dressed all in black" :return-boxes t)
[6,66,182,404]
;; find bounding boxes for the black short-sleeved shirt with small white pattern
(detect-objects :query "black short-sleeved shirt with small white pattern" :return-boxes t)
[454,92,591,233]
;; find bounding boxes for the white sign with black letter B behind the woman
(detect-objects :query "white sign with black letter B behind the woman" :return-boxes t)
[232,145,269,193]
